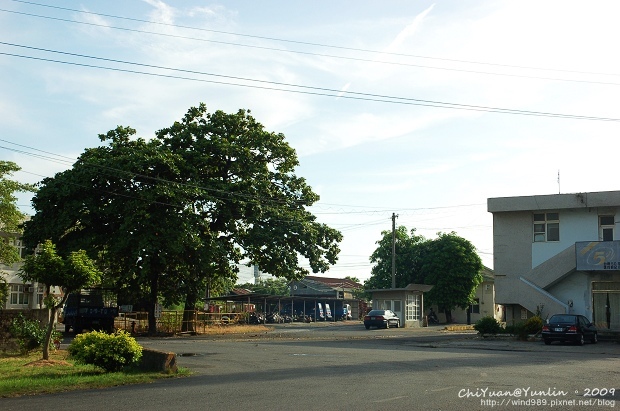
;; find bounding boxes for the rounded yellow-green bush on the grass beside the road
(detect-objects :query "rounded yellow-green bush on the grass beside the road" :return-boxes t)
[67,330,142,372]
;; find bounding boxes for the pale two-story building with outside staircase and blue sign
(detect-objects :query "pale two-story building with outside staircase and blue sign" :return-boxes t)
[487,191,620,330]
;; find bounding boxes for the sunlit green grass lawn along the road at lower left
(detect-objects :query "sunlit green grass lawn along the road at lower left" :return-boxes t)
[0,350,190,398]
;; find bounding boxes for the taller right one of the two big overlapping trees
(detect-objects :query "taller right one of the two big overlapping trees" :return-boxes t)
[157,104,342,323]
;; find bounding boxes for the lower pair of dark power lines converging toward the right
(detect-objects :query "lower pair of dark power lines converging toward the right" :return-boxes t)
[0,42,620,122]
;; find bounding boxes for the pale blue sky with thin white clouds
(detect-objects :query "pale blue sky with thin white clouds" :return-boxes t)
[0,0,620,282]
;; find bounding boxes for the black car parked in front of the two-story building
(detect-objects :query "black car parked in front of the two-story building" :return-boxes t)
[542,314,598,345]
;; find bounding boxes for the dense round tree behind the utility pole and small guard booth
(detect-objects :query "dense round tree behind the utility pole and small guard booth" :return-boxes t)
[364,226,483,321]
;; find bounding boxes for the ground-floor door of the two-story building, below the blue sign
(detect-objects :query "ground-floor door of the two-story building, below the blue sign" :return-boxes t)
[592,281,620,330]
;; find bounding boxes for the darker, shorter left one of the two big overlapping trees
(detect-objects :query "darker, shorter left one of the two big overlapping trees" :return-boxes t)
[24,126,188,332]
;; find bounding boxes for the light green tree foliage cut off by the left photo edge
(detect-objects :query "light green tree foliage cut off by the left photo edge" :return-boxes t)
[0,161,35,268]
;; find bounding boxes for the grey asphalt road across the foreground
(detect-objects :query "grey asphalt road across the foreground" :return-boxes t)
[0,323,620,411]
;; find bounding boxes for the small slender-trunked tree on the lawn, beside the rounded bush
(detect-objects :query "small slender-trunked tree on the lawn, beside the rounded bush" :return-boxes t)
[19,240,101,360]
